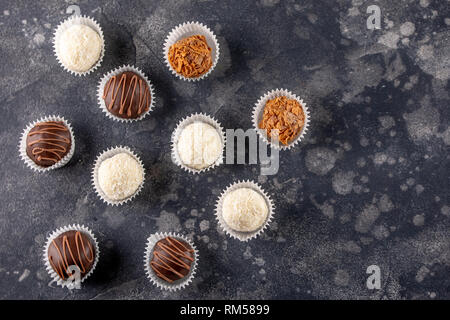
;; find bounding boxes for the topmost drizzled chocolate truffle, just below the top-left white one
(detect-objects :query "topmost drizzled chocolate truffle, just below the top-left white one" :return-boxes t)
[102,71,152,119]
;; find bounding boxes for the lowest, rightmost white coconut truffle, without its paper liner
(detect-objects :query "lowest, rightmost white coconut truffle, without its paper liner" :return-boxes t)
[222,188,269,232]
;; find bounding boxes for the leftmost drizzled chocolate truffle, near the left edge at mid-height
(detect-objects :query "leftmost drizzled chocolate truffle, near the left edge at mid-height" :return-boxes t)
[26,121,72,167]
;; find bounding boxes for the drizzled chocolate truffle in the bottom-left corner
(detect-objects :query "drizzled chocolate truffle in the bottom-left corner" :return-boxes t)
[47,230,97,280]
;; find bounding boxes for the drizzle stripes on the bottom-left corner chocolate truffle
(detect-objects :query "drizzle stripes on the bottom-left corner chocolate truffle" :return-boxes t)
[48,231,95,280]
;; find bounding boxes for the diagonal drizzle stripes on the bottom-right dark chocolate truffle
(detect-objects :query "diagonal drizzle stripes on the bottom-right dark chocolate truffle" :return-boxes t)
[150,237,194,283]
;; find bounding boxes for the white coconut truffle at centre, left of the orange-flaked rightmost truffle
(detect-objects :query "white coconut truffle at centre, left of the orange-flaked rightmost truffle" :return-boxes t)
[177,121,222,170]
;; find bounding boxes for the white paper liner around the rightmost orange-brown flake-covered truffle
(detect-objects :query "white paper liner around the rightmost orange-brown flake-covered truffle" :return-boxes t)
[252,89,309,150]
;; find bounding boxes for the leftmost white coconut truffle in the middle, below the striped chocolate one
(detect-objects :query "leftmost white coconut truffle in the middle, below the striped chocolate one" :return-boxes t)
[98,153,144,201]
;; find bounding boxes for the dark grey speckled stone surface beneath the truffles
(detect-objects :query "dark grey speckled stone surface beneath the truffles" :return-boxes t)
[0,0,450,299]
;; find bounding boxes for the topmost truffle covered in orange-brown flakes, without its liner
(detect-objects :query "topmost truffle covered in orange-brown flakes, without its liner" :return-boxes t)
[168,35,213,78]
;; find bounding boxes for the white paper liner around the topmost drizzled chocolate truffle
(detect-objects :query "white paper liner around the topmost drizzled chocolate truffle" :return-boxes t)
[97,65,155,122]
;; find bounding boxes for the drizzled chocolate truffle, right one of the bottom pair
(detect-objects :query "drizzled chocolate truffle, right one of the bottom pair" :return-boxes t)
[150,237,194,283]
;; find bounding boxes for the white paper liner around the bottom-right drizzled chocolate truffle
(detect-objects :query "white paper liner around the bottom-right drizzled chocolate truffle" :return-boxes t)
[144,232,199,291]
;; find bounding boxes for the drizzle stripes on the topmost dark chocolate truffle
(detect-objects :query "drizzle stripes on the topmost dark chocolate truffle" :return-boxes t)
[102,73,150,116]
